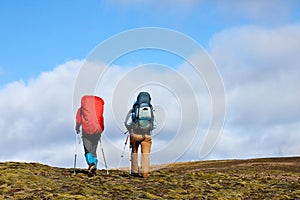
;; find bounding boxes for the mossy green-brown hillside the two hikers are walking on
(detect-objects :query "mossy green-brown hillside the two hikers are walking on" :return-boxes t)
[0,157,300,199]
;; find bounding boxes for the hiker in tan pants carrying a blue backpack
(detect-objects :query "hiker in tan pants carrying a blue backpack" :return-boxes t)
[124,92,156,178]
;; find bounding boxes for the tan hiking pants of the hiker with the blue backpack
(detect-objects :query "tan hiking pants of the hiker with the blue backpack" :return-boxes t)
[130,133,152,173]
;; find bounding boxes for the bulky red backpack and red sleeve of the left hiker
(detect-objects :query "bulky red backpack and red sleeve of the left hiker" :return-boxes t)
[76,96,104,135]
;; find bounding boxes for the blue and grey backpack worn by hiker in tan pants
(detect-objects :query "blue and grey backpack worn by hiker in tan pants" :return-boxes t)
[131,92,154,134]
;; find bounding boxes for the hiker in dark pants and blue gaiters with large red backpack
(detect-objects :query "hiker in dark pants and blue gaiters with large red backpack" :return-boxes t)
[75,95,104,176]
